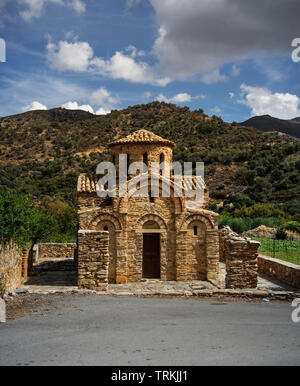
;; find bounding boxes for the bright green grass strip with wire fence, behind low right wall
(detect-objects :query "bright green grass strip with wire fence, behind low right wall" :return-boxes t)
[256,238,300,265]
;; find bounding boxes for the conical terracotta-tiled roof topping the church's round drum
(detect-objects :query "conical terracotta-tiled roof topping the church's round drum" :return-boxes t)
[108,129,176,148]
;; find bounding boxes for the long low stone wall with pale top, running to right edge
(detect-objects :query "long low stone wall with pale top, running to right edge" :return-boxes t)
[258,255,300,288]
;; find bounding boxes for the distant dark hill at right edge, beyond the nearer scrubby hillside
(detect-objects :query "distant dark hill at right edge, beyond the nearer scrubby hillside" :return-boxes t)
[241,115,300,138]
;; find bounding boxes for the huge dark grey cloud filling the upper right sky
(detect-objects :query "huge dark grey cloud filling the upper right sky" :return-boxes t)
[150,0,300,79]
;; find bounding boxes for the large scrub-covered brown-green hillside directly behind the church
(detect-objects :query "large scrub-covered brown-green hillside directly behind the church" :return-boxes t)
[0,102,300,207]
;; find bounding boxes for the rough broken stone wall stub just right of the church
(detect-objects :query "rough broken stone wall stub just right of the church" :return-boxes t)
[219,227,260,289]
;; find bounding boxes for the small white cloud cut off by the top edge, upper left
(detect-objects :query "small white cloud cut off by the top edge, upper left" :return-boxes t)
[18,0,86,21]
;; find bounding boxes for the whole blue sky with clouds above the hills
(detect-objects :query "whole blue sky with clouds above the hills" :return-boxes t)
[0,0,300,122]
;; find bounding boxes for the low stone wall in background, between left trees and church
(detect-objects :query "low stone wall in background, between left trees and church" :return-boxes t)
[35,243,76,260]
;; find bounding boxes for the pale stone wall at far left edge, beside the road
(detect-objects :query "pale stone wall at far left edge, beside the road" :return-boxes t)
[0,243,29,296]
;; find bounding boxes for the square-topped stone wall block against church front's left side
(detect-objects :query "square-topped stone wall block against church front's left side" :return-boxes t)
[78,230,109,291]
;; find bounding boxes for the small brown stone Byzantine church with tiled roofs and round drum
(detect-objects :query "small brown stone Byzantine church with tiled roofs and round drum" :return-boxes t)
[78,130,219,290]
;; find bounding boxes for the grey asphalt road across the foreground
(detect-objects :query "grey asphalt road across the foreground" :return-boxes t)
[0,295,300,366]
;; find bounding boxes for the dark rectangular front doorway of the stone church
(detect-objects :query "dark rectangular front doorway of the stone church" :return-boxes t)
[143,233,160,279]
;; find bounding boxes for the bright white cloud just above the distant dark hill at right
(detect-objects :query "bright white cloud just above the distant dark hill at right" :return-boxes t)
[240,84,300,119]
